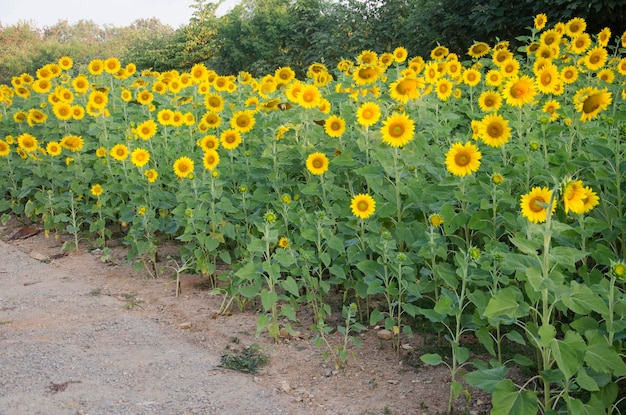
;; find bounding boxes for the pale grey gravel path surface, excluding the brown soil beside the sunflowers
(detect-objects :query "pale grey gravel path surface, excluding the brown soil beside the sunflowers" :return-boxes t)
[0,241,308,415]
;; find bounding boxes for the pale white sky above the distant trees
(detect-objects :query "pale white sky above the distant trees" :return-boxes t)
[0,0,237,29]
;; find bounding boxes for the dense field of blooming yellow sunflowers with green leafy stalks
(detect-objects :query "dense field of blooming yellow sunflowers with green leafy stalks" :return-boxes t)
[0,14,626,414]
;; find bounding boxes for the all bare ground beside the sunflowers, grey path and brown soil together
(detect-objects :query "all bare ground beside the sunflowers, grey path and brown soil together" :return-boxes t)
[0,224,489,415]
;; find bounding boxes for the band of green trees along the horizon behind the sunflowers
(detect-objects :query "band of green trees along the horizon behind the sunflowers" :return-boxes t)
[0,0,626,82]
